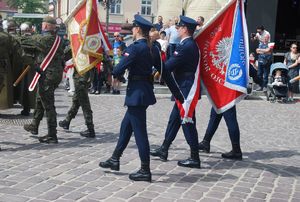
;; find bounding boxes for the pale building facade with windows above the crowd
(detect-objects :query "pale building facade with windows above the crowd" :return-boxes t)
[52,0,228,33]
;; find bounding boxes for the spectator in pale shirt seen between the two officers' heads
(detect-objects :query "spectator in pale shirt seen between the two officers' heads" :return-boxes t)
[166,17,180,58]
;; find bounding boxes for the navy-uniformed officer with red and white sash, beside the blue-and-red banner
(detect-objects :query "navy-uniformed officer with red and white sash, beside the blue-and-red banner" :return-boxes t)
[150,16,200,168]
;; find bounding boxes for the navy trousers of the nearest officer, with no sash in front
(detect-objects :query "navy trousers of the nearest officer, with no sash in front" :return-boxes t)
[116,106,150,162]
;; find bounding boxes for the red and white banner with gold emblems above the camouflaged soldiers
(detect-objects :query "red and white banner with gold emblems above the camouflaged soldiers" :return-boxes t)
[65,0,111,74]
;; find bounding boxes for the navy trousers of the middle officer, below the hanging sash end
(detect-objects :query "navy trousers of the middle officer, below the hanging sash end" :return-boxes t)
[165,103,198,149]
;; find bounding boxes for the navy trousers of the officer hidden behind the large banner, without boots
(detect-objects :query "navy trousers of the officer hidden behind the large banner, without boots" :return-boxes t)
[204,106,240,144]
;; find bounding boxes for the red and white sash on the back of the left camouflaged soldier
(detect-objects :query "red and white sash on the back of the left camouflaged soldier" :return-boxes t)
[28,36,61,91]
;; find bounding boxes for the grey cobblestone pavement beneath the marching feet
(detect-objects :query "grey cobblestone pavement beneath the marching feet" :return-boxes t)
[0,89,300,202]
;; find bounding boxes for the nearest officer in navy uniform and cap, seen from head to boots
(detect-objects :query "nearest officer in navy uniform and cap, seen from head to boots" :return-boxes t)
[99,15,156,182]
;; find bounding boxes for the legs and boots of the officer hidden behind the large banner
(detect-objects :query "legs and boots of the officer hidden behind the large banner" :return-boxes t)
[199,106,243,160]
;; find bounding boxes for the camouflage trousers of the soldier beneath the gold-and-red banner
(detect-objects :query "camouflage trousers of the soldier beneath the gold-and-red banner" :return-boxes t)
[66,72,94,128]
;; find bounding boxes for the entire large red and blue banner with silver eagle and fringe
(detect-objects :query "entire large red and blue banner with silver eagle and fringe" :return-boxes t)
[195,0,249,113]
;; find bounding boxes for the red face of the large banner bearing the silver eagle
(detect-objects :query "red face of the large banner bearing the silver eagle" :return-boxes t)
[195,0,245,113]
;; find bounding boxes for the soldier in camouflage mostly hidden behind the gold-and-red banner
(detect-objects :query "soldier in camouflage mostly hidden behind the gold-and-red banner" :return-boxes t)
[58,46,95,138]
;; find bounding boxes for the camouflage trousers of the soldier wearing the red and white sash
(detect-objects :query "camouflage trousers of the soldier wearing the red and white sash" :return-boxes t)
[33,81,58,135]
